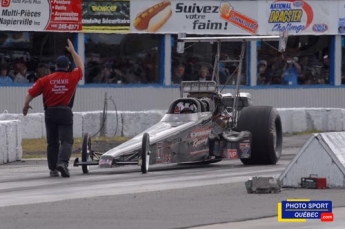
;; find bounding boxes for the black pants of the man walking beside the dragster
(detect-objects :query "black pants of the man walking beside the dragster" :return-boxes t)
[44,107,73,170]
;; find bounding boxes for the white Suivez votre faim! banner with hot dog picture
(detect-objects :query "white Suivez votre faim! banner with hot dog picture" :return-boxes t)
[131,0,258,35]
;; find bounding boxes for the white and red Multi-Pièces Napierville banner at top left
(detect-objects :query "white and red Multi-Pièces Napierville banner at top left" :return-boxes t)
[0,0,81,31]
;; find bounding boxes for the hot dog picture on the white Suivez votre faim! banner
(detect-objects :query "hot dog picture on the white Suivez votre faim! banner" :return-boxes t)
[133,1,172,33]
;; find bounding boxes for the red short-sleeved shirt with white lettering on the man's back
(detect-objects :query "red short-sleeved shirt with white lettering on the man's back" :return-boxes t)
[28,68,83,107]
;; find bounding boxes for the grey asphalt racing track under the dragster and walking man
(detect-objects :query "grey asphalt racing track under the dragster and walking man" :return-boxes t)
[0,135,345,229]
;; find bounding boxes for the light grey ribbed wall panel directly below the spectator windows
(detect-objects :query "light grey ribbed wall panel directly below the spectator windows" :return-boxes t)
[0,84,345,114]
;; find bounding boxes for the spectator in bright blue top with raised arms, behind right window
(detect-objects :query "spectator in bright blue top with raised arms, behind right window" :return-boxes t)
[282,56,301,86]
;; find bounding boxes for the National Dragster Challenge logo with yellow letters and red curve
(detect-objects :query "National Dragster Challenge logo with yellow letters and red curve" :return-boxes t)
[268,0,314,33]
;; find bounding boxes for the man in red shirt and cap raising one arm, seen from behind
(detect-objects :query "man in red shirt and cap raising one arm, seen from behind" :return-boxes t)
[23,39,84,177]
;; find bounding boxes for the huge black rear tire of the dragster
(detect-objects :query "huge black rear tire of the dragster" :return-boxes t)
[237,106,283,165]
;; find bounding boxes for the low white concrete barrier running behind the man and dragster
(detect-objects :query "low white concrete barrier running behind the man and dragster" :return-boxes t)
[0,108,345,164]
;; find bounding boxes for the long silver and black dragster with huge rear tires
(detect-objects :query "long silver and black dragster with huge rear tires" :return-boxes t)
[74,35,283,173]
